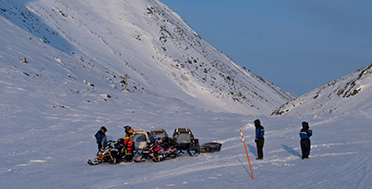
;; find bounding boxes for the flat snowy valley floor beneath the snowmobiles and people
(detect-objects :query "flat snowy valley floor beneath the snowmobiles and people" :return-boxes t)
[0,108,372,188]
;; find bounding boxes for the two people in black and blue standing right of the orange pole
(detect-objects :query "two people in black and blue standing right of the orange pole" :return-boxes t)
[254,119,313,160]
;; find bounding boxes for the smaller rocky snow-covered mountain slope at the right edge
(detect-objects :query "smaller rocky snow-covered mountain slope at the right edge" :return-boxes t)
[273,64,372,115]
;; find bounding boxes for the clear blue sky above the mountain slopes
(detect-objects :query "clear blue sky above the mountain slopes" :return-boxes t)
[160,0,372,96]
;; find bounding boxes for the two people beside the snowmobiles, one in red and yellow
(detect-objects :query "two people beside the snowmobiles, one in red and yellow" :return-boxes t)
[94,125,134,162]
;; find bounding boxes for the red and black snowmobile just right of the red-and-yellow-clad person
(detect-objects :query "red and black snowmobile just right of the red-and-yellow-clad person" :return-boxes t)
[133,137,178,163]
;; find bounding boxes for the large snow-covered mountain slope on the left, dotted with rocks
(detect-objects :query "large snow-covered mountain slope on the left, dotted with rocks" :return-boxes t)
[0,0,294,115]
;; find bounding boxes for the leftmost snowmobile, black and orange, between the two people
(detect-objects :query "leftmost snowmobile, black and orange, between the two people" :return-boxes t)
[87,136,125,165]
